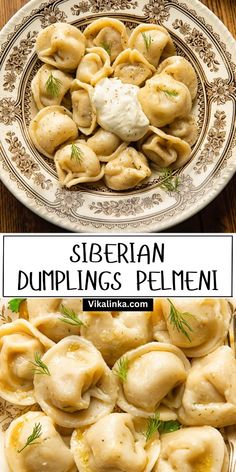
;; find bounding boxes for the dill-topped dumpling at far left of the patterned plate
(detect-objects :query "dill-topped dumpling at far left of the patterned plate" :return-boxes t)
[31,64,73,110]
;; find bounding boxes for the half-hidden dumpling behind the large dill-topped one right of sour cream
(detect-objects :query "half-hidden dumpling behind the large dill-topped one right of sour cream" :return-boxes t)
[157,56,198,100]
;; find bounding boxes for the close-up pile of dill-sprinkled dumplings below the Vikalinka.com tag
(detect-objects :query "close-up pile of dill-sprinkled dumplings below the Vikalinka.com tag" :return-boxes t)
[0,298,236,472]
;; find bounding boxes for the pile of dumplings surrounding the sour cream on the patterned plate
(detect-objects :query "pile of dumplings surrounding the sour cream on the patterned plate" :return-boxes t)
[29,18,198,191]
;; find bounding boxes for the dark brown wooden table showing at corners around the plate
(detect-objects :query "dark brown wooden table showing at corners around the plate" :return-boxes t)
[0,0,236,233]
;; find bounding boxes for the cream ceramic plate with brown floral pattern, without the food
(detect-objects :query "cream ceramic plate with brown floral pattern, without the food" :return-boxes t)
[0,0,236,232]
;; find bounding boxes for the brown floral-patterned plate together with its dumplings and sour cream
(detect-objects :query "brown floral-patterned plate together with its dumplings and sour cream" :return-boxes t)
[0,0,236,233]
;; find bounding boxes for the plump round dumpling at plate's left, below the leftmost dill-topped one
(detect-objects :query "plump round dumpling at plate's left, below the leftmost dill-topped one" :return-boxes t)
[29,105,78,159]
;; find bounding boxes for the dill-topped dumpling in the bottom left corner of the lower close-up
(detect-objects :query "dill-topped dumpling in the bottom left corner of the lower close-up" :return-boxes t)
[5,411,77,472]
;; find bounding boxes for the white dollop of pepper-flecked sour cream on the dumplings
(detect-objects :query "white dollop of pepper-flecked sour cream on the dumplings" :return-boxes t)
[91,78,149,142]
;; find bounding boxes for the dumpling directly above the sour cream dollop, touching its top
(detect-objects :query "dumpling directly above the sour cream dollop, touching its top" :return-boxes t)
[113,49,156,86]
